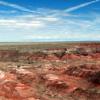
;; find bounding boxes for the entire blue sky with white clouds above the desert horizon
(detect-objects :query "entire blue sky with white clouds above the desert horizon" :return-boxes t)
[0,0,100,42]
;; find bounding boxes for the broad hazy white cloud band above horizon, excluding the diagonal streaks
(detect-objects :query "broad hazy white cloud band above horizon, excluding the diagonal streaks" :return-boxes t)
[0,10,100,40]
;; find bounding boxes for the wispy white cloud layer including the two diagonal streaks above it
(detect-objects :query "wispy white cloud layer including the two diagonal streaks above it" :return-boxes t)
[0,0,100,40]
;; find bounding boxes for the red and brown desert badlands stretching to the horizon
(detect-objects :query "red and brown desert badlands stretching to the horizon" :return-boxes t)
[0,42,100,100]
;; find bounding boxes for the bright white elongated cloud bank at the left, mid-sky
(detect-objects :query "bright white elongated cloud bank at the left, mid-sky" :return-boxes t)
[0,19,44,29]
